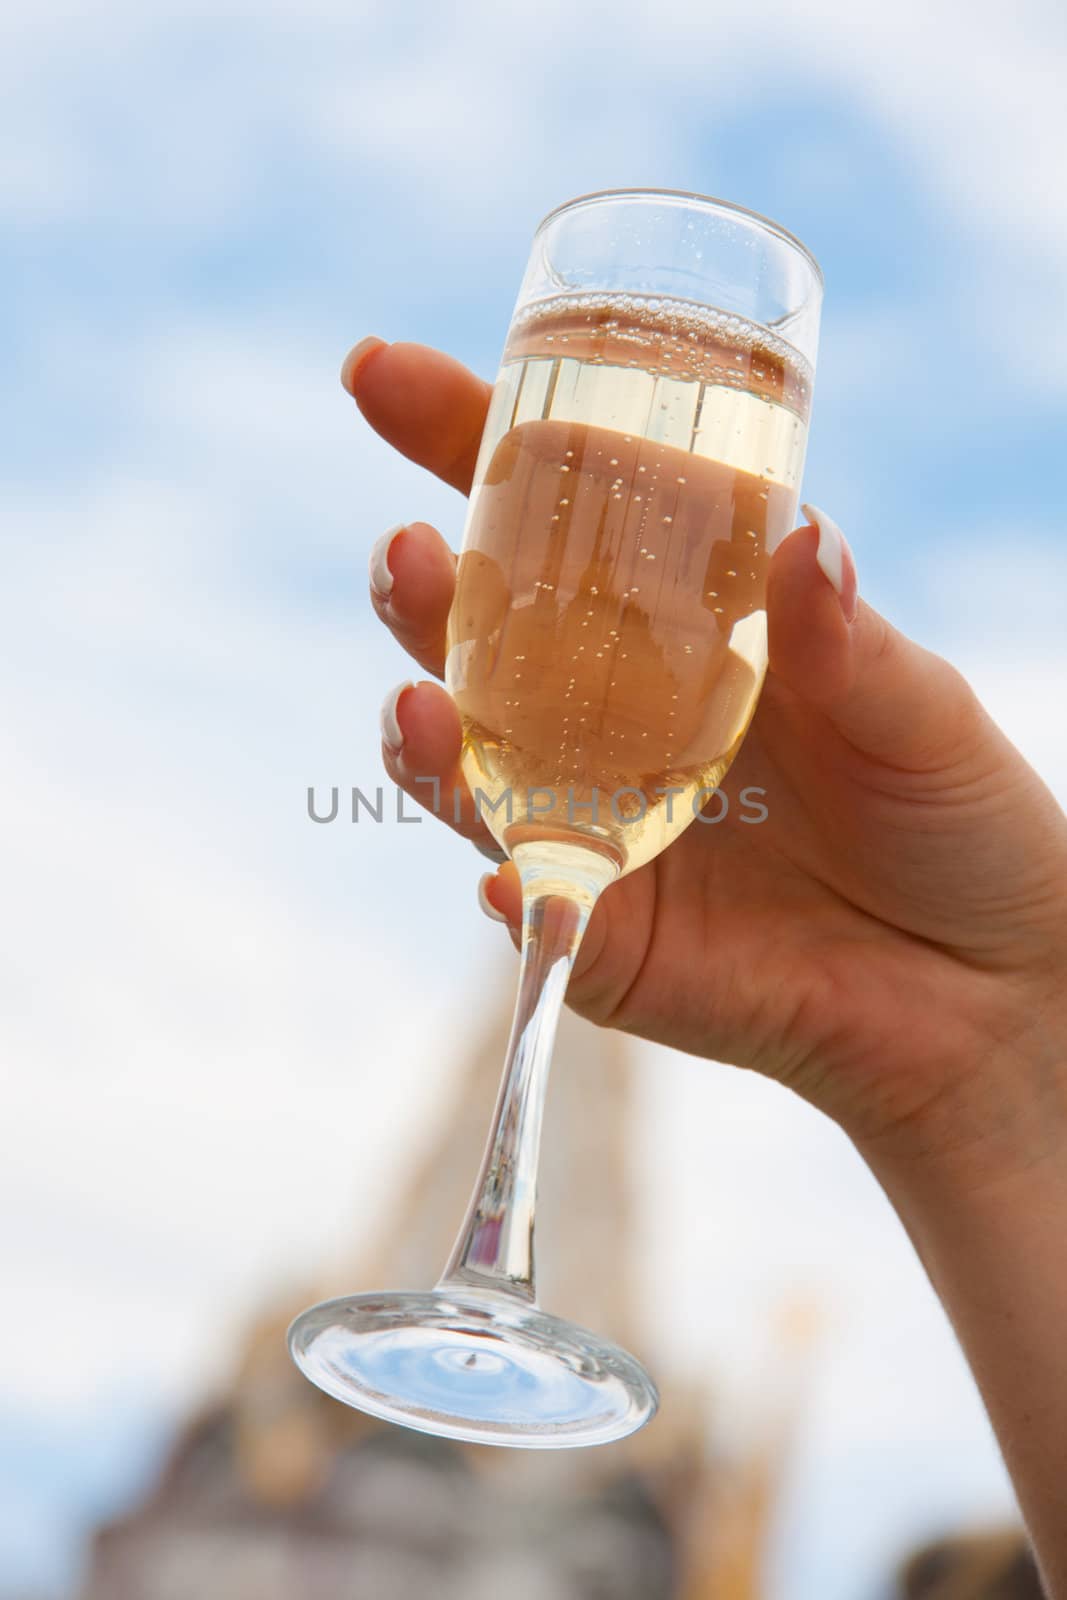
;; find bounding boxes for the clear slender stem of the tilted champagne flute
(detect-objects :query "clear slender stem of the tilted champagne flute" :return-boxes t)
[438,843,617,1301]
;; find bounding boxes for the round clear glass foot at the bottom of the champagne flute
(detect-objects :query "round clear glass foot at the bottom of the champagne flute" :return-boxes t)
[290,1285,659,1450]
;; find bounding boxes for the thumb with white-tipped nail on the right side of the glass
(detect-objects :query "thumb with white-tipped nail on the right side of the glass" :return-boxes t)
[766,506,982,771]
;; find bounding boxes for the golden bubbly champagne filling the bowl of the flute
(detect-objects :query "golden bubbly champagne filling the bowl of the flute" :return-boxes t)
[448,294,811,870]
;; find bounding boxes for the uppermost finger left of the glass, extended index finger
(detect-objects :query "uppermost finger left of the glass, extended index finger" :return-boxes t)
[341,339,493,494]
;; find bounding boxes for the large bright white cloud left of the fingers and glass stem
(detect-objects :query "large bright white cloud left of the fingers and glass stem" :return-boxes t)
[0,416,479,1413]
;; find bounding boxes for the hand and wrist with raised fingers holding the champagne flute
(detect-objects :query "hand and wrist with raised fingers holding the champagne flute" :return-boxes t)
[342,339,1067,1595]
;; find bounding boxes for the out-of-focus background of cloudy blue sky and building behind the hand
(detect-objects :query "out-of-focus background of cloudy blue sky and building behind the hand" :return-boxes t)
[0,0,1067,1600]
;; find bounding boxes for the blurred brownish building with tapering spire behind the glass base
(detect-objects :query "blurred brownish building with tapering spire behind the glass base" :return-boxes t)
[83,1014,776,1600]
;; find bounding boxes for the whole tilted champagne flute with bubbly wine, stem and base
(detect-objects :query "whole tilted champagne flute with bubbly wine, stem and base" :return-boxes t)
[290,190,822,1448]
